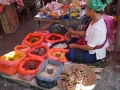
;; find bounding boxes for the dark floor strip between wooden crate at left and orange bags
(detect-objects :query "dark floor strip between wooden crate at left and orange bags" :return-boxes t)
[0,19,36,56]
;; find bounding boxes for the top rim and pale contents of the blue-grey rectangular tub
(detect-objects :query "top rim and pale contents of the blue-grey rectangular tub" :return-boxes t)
[37,58,63,82]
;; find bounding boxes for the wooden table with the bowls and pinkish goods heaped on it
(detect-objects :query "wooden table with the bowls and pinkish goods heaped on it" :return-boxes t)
[34,1,85,30]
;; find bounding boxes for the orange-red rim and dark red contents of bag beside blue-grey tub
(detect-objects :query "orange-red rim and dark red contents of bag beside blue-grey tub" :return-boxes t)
[18,57,44,75]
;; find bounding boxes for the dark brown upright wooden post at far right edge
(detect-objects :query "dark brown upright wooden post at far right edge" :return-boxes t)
[115,0,120,51]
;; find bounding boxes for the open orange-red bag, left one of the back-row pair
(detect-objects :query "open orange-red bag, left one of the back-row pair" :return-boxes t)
[23,33,44,47]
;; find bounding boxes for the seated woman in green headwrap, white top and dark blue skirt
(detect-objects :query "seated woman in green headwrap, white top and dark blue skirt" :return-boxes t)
[66,0,111,63]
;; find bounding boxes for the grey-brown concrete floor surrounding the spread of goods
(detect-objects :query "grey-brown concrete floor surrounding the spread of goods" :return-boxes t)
[0,19,120,90]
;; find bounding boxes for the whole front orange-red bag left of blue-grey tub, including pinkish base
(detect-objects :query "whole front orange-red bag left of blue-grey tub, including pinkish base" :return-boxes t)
[18,57,44,81]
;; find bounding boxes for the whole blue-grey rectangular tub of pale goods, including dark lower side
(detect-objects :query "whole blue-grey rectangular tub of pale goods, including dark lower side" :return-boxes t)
[36,58,63,88]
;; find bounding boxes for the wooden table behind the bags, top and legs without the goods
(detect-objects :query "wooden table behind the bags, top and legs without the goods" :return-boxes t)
[34,11,85,31]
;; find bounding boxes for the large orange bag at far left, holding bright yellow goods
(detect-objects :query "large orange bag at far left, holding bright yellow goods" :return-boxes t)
[0,51,26,75]
